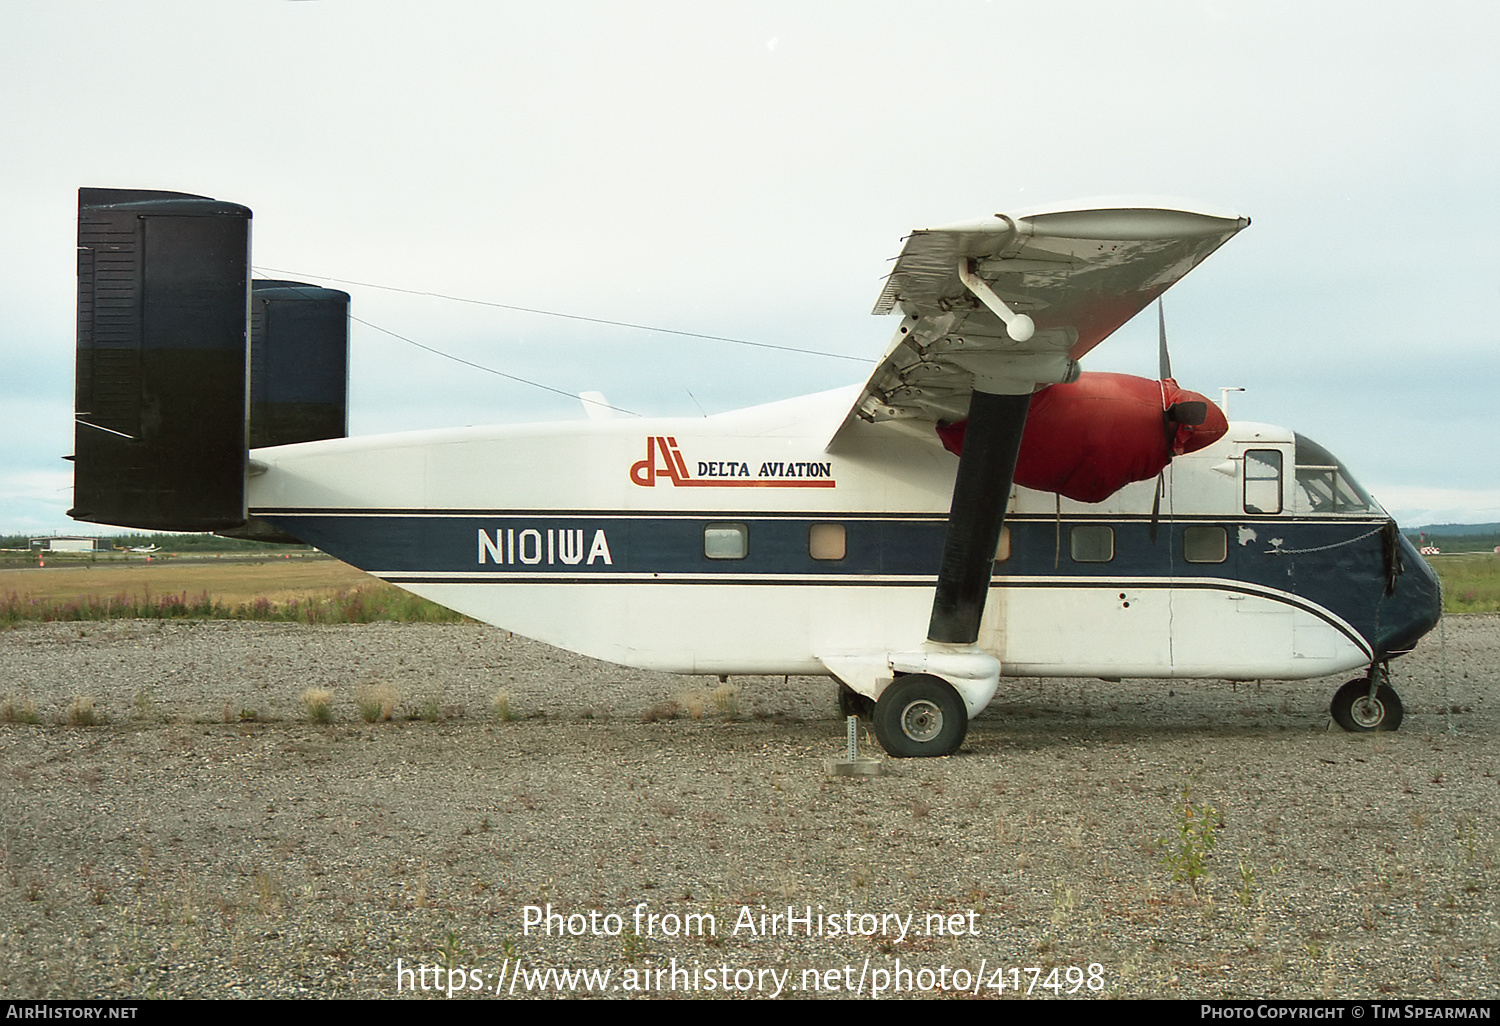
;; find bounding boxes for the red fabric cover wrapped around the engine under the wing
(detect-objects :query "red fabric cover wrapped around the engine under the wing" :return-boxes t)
[938,374,1229,503]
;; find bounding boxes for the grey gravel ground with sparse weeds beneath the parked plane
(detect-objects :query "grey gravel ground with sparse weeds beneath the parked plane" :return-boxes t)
[0,617,1500,999]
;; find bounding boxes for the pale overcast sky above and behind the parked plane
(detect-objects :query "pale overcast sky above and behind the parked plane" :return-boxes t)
[0,0,1500,533]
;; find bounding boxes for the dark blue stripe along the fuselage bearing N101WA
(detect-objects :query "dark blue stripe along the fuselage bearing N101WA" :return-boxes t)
[255,510,1404,647]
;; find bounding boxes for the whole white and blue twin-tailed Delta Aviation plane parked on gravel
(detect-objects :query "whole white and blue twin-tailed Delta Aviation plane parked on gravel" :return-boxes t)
[72,189,1440,756]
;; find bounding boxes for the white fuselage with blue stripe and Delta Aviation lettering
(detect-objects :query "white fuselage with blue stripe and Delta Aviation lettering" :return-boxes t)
[249,390,1404,693]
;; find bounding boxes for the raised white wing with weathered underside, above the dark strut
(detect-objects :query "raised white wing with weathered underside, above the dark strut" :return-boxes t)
[834,206,1250,438]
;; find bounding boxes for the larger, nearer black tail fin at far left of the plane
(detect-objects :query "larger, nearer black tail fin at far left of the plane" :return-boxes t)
[69,189,251,531]
